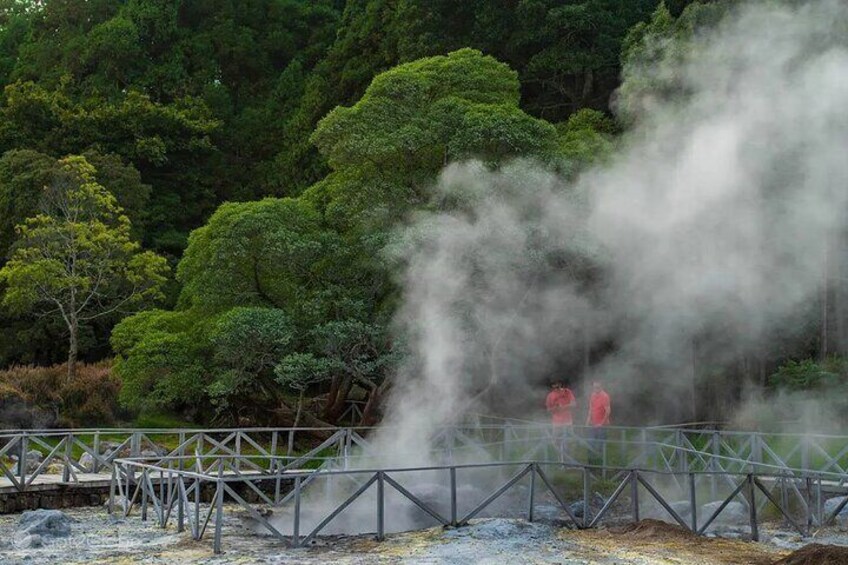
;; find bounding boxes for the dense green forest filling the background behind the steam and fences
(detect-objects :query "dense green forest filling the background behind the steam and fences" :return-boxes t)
[0,0,848,425]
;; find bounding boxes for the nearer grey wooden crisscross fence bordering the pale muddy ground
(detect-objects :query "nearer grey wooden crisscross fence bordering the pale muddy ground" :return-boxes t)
[109,455,848,553]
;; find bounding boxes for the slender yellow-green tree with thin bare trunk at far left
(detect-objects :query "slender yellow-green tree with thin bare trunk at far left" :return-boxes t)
[0,156,167,379]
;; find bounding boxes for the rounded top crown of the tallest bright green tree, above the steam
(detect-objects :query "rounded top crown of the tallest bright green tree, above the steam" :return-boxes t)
[304,49,556,234]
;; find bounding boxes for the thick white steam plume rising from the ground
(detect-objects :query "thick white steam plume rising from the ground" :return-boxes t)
[379,1,848,464]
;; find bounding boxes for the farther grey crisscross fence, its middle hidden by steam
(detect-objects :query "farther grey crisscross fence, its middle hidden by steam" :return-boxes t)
[0,421,848,492]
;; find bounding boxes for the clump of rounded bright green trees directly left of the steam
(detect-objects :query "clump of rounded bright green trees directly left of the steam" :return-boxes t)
[112,49,584,422]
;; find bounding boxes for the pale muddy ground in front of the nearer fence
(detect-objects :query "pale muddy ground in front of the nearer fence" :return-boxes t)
[0,508,848,565]
